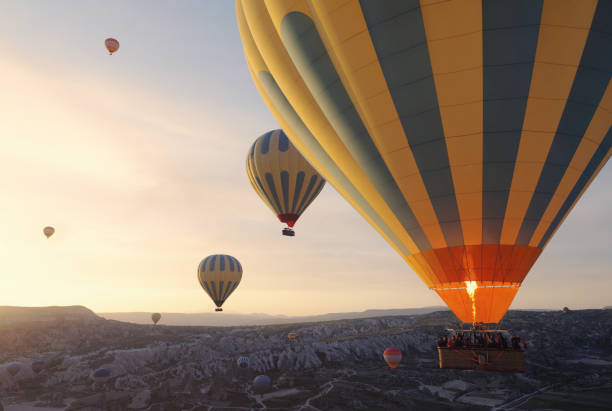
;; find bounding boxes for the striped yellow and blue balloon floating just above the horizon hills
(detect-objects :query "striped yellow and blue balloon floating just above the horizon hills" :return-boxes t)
[198,254,242,311]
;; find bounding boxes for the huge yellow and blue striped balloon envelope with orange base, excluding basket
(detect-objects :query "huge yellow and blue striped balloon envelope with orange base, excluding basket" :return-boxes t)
[237,0,612,323]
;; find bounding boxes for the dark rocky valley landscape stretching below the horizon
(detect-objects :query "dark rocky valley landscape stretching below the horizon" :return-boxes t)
[0,306,612,411]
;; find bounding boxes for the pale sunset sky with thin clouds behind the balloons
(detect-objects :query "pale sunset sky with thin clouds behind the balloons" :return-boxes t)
[0,0,612,315]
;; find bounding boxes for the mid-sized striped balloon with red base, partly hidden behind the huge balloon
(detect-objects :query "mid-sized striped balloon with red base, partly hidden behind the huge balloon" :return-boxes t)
[246,130,325,236]
